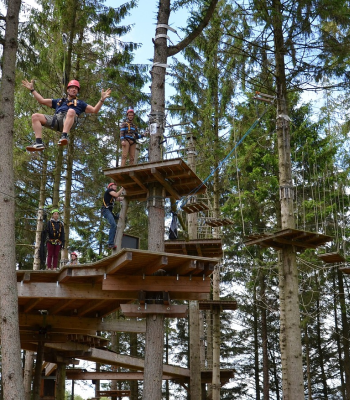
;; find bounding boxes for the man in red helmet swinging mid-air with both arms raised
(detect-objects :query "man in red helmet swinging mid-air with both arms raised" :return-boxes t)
[22,79,111,151]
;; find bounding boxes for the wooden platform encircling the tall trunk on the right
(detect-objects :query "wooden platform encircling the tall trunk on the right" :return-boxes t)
[244,229,333,251]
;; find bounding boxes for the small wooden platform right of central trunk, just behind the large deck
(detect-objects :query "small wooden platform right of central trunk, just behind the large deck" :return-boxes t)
[164,239,223,258]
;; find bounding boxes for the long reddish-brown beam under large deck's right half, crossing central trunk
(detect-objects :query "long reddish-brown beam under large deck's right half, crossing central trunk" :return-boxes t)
[102,275,210,298]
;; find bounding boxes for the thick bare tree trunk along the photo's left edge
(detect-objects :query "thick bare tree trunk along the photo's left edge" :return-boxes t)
[0,0,24,400]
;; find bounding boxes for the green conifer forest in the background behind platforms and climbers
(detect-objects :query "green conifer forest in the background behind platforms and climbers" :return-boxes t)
[0,0,350,399]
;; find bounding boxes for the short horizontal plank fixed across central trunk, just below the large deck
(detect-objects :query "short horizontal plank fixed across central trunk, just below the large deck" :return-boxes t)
[120,304,188,318]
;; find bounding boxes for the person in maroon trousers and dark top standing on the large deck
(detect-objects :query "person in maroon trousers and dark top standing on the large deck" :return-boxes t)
[46,209,65,270]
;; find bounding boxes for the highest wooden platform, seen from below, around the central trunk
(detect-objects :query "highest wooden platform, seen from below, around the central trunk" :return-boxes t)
[103,158,207,201]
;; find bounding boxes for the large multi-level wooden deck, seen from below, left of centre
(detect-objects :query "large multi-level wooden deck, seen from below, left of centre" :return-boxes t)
[17,249,218,318]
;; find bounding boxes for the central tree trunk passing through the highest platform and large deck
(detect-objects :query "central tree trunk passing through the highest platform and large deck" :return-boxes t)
[142,0,170,400]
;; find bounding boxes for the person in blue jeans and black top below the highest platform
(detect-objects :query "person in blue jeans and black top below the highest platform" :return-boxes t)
[101,182,124,249]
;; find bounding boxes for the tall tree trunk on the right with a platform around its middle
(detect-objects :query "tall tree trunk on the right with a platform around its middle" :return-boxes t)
[273,0,304,400]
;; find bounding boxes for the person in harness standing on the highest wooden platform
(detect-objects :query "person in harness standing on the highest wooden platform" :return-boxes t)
[120,108,145,167]
